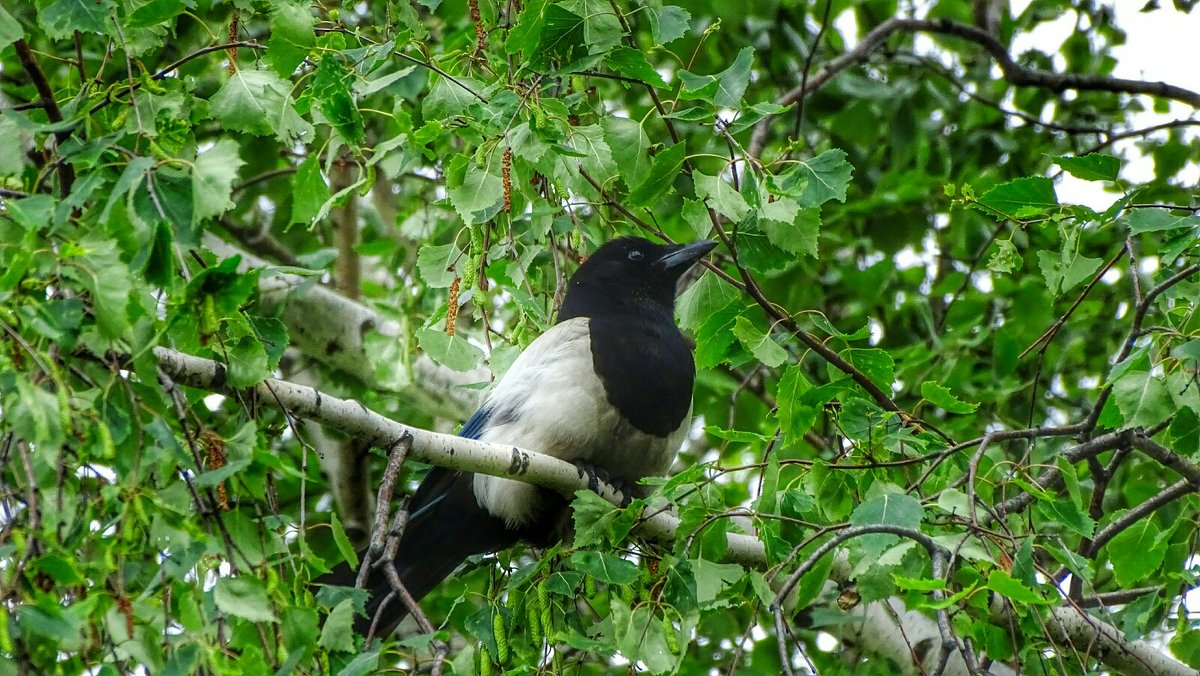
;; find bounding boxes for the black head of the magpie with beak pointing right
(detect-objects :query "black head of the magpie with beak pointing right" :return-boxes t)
[558,237,716,322]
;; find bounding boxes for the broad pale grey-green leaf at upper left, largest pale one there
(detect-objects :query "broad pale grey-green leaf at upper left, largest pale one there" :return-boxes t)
[211,68,313,144]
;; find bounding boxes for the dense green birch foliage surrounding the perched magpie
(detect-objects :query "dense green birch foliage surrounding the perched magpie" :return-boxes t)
[0,0,1200,674]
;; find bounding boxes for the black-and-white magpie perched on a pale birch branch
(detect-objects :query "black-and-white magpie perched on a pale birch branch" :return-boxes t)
[316,237,716,638]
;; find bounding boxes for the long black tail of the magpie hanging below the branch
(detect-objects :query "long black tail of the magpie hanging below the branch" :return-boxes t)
[316,469,518,636]
